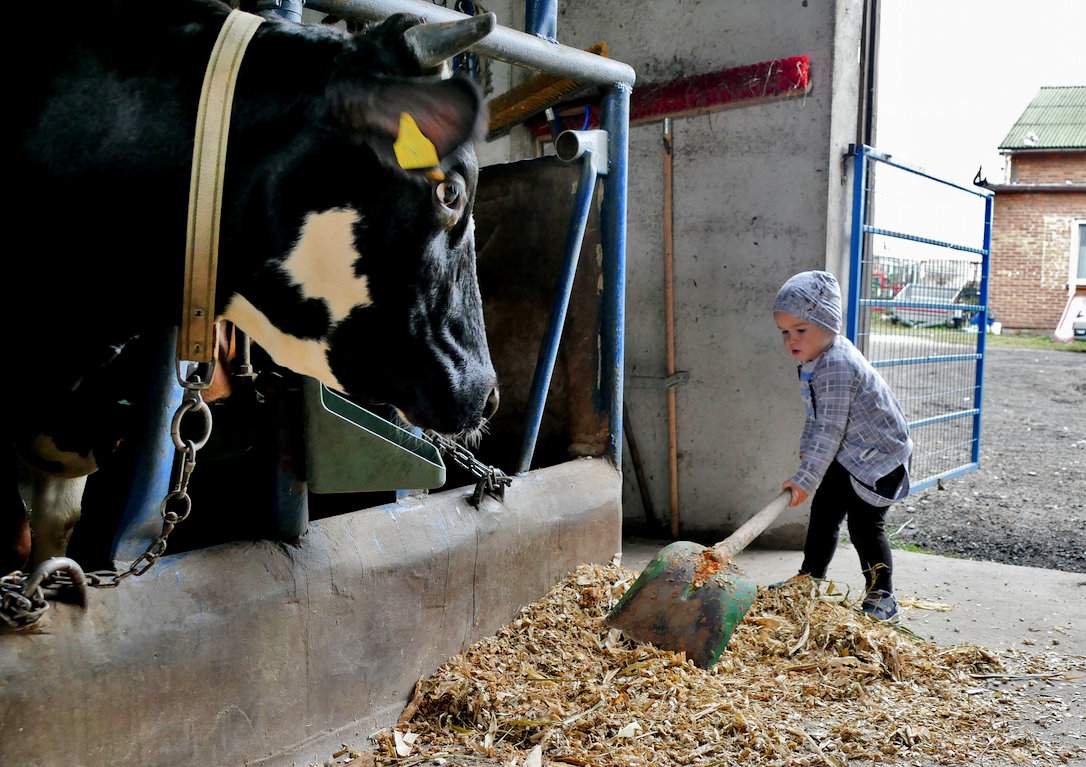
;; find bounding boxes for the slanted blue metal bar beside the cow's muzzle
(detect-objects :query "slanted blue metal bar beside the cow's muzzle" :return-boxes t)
[517,152,596,474]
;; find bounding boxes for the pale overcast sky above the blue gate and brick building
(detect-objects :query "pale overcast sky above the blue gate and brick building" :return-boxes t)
[872,0,1086,247]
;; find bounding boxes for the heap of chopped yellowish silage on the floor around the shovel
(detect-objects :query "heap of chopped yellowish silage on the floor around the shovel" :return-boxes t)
[375,565,1068,767]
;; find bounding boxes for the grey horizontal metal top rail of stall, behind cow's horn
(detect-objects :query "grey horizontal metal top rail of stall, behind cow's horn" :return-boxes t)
[305,0,635,86]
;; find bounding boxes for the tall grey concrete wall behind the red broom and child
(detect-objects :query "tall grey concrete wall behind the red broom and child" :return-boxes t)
[558,0,862,543]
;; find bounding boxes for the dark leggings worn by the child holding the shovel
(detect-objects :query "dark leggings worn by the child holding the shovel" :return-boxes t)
[799,461,905,591]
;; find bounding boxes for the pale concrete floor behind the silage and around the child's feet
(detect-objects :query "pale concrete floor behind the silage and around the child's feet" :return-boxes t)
[622,539,1086,766]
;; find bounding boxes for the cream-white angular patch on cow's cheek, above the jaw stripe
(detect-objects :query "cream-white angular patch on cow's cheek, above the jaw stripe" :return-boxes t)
[280,208,372,325]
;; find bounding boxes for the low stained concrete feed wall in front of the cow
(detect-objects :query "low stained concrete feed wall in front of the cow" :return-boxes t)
[0,458,621,767]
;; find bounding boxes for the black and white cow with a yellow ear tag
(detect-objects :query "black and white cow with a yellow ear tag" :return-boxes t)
[6,0,497,574]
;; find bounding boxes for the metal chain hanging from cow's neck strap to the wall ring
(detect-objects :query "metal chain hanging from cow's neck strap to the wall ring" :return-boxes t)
[0,366,214,628]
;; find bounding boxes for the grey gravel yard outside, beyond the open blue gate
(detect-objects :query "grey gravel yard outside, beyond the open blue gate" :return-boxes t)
[887,348,1086,573]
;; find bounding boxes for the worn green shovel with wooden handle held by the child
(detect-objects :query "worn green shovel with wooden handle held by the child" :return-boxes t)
[606,491,791,668]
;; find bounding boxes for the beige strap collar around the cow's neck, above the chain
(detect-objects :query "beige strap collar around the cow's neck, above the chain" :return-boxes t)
[177,10,264,362]
